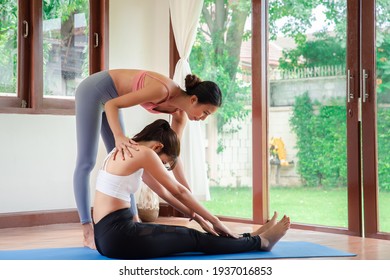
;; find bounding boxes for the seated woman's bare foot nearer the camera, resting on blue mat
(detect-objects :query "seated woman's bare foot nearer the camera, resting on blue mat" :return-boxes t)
[259,215,290,251]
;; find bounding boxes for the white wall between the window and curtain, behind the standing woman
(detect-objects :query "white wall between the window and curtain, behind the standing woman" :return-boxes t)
[109,0,169,135]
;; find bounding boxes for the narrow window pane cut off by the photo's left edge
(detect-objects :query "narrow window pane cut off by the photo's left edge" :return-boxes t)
[0,0,18,96]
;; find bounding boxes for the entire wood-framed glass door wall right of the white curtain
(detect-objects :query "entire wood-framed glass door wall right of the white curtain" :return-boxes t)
[190,0,390,241]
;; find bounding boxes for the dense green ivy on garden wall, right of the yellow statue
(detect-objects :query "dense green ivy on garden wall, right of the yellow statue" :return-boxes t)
[290,92,347,187]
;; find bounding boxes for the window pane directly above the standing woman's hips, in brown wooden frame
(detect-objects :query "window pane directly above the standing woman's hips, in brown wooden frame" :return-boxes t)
[43,0,89,97]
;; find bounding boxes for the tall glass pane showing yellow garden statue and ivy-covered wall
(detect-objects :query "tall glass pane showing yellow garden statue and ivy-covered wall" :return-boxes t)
[268,0,348,227]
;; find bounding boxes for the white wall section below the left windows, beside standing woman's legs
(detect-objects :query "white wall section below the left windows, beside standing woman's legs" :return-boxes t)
[0,114,76,213]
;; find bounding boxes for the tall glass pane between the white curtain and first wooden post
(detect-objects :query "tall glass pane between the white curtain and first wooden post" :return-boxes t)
[194,0,253,218]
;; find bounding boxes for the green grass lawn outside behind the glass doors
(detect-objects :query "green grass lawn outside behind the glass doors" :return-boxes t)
[202,187,390,232]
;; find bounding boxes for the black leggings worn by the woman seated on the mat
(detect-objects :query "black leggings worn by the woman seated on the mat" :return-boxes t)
[94,208,261,259]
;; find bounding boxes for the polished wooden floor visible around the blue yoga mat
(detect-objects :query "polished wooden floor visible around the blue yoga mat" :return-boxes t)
[0,217,390,260]
